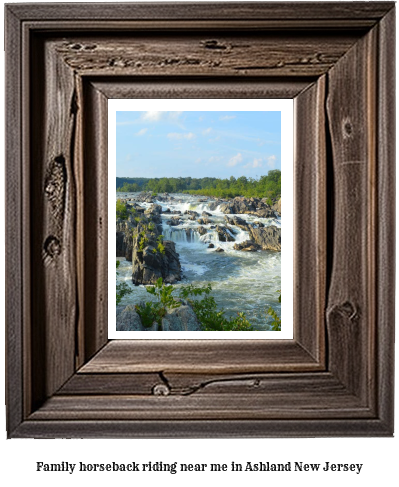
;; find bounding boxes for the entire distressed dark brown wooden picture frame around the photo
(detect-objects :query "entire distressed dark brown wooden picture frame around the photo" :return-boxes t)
[6,2,395,438]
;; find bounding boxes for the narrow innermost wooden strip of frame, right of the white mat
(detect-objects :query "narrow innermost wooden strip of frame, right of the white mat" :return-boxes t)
[294,76,327,364]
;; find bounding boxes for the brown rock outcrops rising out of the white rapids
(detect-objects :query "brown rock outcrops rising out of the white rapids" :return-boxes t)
[116,193,281,285]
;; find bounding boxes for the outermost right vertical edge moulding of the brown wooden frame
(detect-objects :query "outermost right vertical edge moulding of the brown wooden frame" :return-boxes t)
[376,9,396,435]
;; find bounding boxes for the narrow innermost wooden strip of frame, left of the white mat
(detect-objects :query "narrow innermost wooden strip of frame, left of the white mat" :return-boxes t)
[83,83,108,363]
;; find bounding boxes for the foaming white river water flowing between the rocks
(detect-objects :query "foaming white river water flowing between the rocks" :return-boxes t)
[117,193,281,330]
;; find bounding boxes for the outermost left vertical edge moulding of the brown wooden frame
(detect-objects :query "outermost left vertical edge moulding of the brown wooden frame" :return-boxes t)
[5,6,26,436]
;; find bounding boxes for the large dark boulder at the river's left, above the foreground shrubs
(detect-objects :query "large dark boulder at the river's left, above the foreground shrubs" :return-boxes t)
[132,240,181,285]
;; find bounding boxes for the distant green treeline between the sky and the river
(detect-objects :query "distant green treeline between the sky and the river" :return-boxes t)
[116,169,281,199]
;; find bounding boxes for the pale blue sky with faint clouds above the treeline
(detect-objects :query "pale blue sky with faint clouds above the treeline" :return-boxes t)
[116,111,281,178]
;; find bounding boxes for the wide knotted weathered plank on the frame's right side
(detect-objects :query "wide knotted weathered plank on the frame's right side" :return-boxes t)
[327,30,376,404]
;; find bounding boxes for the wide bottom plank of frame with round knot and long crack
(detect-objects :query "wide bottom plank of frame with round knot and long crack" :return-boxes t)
[30,373,373,421]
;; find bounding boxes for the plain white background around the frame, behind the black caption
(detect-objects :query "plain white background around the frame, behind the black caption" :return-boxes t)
[0,0,399,487]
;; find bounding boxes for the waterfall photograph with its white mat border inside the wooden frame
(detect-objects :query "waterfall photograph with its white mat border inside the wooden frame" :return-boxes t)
[108,99,293,340]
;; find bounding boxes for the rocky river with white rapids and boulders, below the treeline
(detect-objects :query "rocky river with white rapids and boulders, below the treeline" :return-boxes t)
[116,193,281,331]
